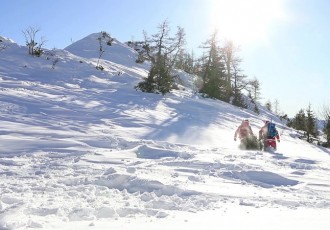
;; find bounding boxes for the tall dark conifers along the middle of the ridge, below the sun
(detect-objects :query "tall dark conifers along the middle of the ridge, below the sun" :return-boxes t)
[129,21,260,112]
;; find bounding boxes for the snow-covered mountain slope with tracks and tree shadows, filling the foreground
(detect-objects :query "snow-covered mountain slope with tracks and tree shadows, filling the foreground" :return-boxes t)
[0,34,330,230]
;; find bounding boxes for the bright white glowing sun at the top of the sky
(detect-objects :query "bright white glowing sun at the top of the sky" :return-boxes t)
[208,0,285,44]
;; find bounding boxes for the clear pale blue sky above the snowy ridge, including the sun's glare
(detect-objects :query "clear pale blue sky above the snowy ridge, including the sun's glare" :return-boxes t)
[0,0,330,116]
